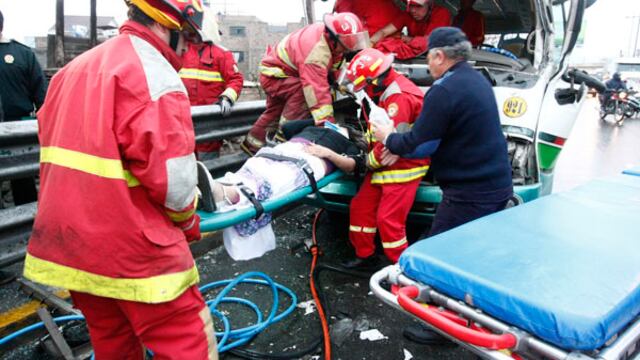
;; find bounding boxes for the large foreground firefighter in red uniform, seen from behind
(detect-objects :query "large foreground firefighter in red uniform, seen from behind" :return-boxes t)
[24,0,218,360]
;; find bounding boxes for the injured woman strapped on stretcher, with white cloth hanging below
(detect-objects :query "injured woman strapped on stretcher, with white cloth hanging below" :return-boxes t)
[198,120,367,260]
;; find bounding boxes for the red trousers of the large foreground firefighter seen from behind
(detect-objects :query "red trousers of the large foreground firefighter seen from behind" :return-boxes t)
[71,286,218,360]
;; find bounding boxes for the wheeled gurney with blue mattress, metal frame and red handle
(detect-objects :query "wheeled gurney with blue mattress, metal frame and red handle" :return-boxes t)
[370,172,640,360]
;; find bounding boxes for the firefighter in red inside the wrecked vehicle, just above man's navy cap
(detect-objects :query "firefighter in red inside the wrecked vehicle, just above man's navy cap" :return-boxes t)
[371,0,451,60]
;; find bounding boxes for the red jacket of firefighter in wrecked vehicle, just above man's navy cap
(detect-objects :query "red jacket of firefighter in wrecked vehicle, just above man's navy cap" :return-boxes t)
[374,3,451,59]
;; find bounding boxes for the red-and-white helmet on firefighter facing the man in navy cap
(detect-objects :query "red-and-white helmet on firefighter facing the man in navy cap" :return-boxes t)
[346,48,393,92]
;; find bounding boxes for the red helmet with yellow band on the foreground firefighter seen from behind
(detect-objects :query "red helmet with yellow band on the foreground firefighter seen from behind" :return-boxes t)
[125,0,203,41]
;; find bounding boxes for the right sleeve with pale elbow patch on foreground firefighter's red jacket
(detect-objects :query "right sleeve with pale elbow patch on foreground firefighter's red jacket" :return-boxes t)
[119,91,197,231]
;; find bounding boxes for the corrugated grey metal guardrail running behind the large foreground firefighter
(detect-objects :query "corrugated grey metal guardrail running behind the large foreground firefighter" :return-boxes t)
[0,101,265,268]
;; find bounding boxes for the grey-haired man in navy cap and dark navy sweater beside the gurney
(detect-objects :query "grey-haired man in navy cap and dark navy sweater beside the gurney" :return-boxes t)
[372,27,513,343]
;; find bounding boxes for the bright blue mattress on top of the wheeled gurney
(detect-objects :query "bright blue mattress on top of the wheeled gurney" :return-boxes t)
[399,175,640,350]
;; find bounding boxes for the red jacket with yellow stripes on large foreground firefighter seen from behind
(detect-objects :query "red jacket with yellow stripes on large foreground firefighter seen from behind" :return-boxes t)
[24,21,199,303]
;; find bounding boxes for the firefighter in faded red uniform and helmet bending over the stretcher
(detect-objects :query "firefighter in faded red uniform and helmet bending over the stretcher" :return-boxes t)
[242,13,369,154]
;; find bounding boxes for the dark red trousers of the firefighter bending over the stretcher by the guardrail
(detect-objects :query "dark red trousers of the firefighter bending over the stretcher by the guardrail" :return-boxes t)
[247,75,311,147]
